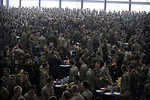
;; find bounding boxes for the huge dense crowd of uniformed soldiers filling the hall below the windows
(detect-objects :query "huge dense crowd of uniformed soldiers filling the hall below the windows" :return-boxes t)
[0,6,150,100]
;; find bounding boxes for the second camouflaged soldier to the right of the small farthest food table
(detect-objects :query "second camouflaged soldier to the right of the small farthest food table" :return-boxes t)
[79,58,88,81]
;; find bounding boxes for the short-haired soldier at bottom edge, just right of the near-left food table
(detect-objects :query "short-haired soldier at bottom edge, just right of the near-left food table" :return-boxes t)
[71,85,85,100]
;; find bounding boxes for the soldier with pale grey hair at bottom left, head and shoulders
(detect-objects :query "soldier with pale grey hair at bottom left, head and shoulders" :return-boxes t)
[11,86,25,100]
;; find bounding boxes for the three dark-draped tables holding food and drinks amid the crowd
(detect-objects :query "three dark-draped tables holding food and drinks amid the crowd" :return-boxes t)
[53,65,121,100]
